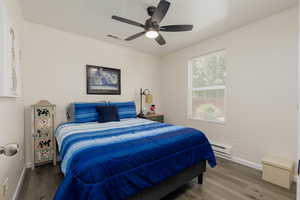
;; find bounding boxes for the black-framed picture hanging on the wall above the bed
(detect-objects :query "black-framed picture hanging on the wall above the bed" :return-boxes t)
[86,65,121,95]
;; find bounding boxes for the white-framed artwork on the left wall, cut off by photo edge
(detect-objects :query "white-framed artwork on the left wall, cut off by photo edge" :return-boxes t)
[0,2,21,97]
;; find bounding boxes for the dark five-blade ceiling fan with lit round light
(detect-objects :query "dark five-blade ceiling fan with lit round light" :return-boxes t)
[112,0,193,45]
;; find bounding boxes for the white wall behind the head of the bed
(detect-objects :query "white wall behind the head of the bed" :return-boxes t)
[23,22,160,166]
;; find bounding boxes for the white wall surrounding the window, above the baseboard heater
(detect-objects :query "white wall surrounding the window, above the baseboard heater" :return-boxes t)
[161,8,298,166]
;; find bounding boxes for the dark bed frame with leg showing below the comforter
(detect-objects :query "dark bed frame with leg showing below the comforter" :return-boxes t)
[129,161,206,200]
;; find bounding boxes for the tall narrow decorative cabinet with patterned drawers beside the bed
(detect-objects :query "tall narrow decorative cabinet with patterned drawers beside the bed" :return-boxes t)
[31,100,56,167]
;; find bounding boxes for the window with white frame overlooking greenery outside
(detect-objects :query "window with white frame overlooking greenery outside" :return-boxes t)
[188,50,226,122]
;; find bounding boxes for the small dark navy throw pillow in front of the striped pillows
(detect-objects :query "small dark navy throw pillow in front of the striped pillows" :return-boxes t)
[97,106,120,123]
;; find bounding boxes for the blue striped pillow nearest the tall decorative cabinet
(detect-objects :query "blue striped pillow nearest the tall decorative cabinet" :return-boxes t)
[70,102,107,123]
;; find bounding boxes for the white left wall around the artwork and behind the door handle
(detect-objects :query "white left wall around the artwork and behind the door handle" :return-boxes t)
[0,0,24,199]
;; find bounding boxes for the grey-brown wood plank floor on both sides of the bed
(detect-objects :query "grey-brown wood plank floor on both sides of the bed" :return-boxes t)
[18,160,296,200]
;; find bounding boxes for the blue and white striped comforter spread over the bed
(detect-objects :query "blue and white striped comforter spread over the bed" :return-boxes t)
[55,118,216,200]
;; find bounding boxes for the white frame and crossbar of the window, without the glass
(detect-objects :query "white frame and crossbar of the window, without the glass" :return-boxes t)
[187,48,228,125]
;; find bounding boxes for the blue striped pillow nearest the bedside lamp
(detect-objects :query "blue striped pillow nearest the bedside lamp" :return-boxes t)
[109,101,136,119]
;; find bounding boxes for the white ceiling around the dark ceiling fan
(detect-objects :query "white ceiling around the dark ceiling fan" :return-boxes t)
[20,0,298,55]
